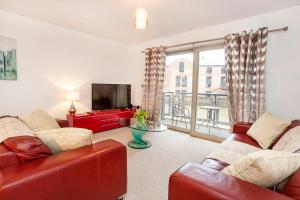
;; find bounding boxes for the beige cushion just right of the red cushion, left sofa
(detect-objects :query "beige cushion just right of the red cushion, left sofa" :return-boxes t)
[35,128,92,153]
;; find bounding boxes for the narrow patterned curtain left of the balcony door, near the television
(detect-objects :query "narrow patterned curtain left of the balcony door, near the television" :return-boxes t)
[142,47,166,126]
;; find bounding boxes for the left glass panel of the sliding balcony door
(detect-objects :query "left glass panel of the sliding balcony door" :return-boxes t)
[161,52,193,131]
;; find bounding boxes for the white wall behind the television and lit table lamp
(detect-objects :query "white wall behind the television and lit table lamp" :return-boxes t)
[0,11,131,117]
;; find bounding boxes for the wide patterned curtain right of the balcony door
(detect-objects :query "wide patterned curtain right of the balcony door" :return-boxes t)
[225,28,268,124]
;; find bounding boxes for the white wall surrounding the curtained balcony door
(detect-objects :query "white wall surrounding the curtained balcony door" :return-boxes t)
[130,6,300,119]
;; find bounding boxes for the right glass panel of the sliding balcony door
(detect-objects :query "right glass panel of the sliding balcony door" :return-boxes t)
[194,47,230,138]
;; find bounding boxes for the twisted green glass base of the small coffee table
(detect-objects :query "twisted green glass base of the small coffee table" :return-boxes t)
[128,129,151,149]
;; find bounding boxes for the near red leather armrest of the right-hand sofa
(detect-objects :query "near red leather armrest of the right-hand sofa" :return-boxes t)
[169,163,291,200]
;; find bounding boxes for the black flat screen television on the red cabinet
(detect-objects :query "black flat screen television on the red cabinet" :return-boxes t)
[92,83,131,110]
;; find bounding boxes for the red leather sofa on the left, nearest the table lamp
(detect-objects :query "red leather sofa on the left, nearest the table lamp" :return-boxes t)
[0,121,127,200]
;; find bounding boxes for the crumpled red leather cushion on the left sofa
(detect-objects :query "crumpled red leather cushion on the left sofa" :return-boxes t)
[3,136,52,161]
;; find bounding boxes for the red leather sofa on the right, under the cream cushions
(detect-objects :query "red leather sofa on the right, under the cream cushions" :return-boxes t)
[169,120,300,200]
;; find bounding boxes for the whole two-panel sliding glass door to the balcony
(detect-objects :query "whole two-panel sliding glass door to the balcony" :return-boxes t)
[161,46,229,140]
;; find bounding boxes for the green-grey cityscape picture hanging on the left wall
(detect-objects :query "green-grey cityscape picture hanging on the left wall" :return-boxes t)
[0,36,18,80]
